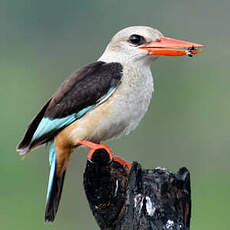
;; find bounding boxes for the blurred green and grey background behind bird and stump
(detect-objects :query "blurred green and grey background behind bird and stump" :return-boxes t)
[0,0,230,230]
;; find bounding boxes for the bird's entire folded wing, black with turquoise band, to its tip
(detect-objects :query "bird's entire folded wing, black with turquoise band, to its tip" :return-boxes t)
[17,61,122,154]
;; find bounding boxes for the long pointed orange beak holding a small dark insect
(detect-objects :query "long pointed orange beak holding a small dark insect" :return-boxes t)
[140,37,203,57]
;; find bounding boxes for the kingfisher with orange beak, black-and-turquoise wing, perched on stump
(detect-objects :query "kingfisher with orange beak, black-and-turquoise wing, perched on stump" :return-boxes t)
[17,26,202,222]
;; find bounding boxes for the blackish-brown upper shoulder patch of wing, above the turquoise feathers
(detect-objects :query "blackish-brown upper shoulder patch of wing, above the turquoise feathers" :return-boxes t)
[45,61,122,118]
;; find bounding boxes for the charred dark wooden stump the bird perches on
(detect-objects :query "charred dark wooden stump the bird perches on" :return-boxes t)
[84,149,191,230]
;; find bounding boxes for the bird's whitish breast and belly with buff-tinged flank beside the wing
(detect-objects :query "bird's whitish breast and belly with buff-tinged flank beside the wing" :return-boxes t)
[73,64,153,142]
